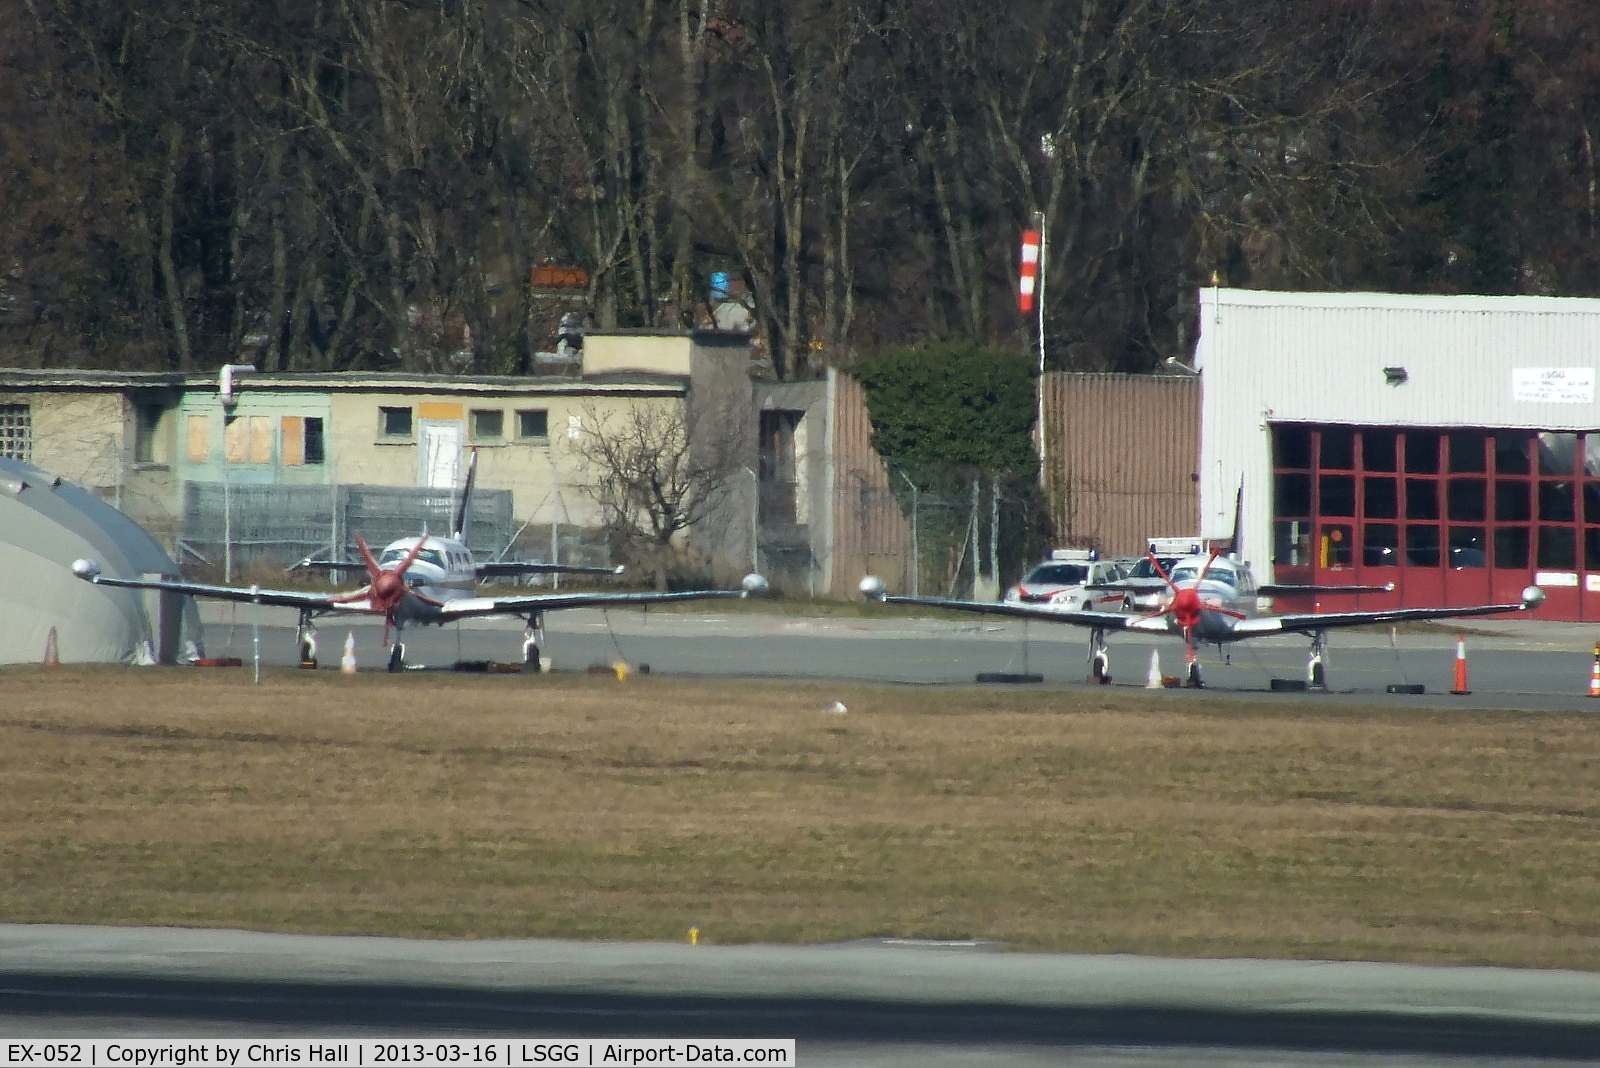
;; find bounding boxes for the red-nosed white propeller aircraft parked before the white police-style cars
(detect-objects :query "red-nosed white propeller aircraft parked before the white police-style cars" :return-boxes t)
[861,550,1544,689]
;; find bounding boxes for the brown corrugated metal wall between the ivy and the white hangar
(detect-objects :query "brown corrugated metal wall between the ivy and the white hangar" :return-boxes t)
[1045,374,1200,556]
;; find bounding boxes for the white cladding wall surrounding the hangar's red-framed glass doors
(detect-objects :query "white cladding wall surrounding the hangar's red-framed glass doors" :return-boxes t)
[1195,288,1600,580]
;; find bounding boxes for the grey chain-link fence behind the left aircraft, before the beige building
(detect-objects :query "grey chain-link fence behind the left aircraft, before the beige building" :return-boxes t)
[178,481,610,582]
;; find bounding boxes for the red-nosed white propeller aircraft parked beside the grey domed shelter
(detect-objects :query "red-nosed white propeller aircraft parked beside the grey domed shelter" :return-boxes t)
[72,452,768,671]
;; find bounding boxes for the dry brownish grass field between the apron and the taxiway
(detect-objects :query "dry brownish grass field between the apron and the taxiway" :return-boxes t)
[0,668,1600,970]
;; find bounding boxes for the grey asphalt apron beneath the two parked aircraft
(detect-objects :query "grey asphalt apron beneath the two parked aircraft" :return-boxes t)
[181,604,1600,711]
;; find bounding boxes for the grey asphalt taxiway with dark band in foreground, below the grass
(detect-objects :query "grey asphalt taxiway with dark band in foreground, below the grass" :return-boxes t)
[0,926,1600,1066]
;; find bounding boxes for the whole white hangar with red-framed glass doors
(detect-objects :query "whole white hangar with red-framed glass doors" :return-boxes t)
[1195,288,1600,620]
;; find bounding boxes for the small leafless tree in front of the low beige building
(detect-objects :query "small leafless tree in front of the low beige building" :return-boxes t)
[568,403,742,590]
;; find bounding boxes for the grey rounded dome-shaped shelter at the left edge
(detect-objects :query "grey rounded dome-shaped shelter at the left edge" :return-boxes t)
[0,457,200,664]
